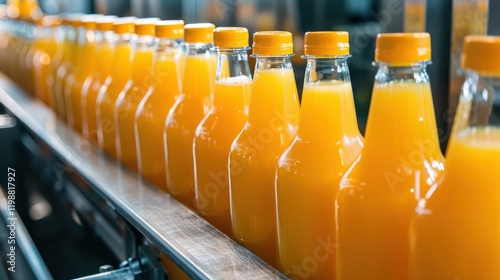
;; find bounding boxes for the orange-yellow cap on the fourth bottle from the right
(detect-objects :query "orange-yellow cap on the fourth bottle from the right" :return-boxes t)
[252,31,293,55]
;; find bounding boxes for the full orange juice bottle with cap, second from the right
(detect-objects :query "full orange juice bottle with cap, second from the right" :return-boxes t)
[336,33,444,279]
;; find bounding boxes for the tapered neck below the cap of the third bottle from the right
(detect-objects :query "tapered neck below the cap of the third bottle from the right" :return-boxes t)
[298,57,360,140]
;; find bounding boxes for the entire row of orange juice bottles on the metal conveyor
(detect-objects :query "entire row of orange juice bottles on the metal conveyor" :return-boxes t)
[0,10,500,279]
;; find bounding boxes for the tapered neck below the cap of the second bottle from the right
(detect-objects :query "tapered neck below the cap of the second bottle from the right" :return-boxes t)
[365,62,442,159]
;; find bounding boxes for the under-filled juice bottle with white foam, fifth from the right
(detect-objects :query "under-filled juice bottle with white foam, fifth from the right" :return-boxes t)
[193,27,252,237]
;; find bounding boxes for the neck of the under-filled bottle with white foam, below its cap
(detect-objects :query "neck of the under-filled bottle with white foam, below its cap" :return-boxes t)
[214,48,252,110]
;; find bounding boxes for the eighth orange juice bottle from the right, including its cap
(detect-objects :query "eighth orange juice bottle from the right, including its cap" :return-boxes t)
[114,18,159,172]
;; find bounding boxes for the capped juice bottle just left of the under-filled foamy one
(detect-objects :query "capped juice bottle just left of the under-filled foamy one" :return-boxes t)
[164,23,215,210]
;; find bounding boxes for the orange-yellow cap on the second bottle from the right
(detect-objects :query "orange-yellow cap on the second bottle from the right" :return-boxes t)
[375,32,431,65]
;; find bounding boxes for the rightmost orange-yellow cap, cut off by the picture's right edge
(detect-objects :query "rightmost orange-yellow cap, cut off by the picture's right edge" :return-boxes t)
[461,35,500,76]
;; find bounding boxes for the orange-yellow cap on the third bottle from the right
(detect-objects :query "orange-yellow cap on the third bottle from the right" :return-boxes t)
[304,31,349,56]
